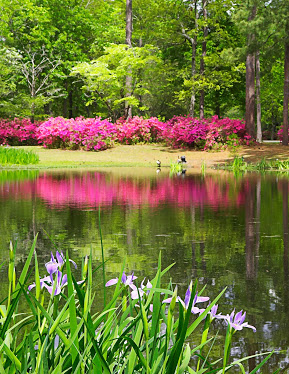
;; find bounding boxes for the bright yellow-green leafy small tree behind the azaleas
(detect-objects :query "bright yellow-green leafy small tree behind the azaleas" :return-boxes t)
[72,44,161,120]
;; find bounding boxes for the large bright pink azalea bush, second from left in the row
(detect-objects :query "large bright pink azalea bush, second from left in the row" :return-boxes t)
[37,117,116,151]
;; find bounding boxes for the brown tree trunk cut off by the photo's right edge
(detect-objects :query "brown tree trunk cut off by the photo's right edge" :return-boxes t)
[282,21,289,145]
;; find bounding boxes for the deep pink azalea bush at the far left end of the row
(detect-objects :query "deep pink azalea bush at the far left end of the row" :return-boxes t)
[0,118,40,145]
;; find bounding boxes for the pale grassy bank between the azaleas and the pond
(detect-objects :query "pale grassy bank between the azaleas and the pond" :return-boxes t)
[0,144,289,170]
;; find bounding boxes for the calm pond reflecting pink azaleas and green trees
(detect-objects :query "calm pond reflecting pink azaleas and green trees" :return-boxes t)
[0,168,289,373]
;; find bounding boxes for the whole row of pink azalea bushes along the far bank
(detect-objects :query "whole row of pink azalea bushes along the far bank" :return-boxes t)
[0,116,250,151]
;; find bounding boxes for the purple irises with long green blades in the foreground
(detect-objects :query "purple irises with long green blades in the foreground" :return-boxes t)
[0,237,277,374]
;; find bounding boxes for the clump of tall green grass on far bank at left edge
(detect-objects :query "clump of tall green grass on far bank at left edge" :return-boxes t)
[0,146,39,165]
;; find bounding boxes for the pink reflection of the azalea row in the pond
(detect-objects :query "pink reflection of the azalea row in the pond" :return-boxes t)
[0,172,248,209]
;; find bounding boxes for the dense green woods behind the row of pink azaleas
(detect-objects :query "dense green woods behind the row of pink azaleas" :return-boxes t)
[0,0,289,140]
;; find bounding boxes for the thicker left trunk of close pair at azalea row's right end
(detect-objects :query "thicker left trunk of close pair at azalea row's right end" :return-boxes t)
[246,5,257,138]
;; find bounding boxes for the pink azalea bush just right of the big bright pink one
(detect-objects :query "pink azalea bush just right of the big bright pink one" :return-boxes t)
[115,116,164,144]
